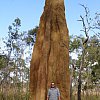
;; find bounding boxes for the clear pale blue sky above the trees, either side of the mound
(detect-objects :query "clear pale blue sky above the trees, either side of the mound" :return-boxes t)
[0,0,100,39]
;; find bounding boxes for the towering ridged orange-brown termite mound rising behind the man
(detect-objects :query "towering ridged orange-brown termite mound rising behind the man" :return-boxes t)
[30,0,70,100]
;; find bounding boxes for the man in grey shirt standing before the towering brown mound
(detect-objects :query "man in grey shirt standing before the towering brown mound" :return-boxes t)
[47,82,60,100]
